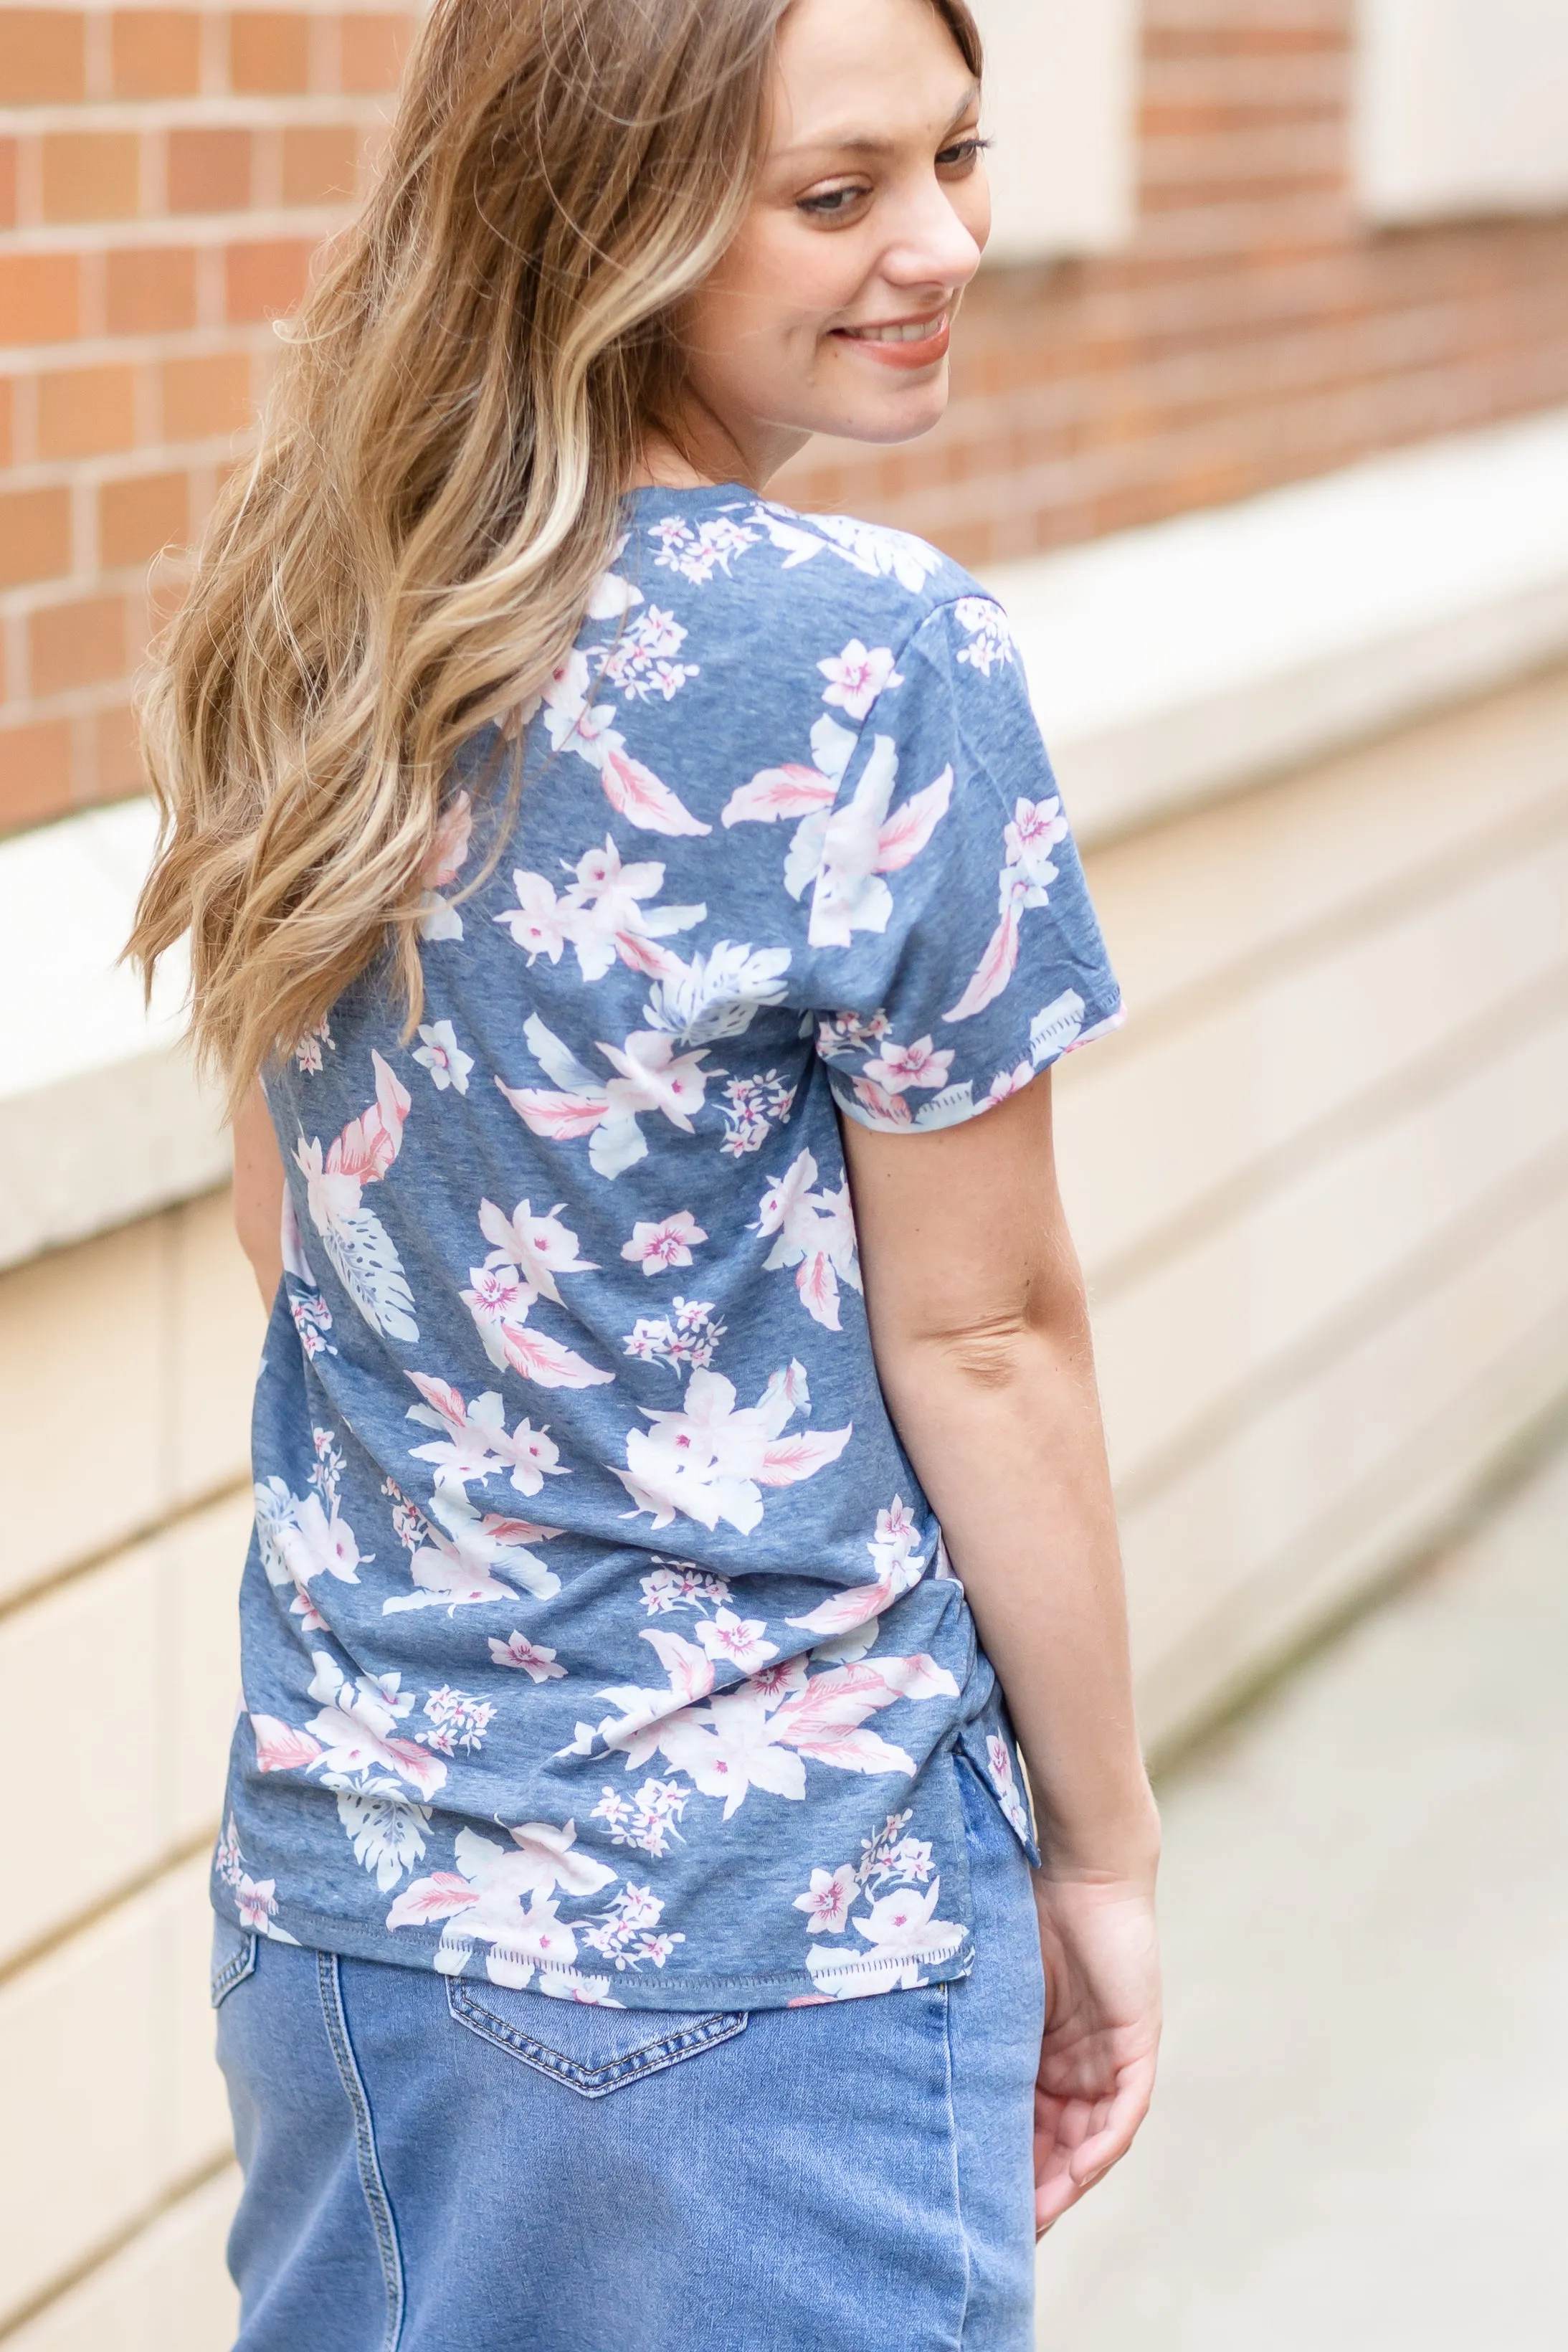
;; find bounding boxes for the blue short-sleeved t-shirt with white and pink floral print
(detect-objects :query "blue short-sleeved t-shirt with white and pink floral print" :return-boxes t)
[214,487,1116,2009]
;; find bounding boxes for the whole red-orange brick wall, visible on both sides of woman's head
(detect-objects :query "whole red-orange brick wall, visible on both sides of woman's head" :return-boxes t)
[0,0,1568,825]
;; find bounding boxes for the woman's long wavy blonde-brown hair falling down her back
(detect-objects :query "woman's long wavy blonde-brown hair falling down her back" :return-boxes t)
[127,0,980,1103]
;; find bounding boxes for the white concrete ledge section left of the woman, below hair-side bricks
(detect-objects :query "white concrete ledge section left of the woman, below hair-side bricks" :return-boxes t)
[0,800,228,1268]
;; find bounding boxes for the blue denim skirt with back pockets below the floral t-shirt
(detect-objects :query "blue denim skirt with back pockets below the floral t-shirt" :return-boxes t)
[214,1762,1044,2352]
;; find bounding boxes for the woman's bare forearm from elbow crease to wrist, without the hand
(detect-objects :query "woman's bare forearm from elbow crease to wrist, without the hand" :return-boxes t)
[879,1299,1159,1877]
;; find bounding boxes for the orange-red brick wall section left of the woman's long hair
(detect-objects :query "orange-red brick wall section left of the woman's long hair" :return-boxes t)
[0,0,407,825]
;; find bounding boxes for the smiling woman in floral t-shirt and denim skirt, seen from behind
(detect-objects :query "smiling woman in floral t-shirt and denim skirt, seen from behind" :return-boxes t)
[136,0,1159,2352]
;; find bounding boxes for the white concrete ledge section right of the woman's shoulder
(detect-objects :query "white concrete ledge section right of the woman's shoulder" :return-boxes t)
[987,409,1568,847]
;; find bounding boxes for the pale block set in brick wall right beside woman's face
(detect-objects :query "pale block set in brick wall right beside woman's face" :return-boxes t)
[973,0,1140,261]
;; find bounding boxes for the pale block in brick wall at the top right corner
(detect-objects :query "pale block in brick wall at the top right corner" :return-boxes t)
[1354,0,1568,221]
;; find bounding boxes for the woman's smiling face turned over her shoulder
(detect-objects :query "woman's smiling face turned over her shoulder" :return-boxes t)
[682,0,989,487]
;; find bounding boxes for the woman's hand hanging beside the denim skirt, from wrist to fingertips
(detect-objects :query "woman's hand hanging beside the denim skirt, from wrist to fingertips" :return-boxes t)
[1035,1870,1159,2234]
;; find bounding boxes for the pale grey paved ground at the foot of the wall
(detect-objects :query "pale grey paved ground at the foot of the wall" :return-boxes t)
[1039,1456,1568,2352]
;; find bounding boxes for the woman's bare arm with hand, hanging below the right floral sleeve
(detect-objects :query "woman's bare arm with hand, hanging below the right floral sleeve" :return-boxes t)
[844,1075,1159,2227]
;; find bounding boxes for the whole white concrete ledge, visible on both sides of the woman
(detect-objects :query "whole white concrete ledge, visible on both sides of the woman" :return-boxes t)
[0,409,1568,1268]
